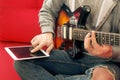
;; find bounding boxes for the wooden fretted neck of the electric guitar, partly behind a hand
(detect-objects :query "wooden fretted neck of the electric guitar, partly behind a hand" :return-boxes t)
[72,28,120,46]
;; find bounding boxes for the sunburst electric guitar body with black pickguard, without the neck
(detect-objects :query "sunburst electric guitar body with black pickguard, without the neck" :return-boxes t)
[54,5,90,58]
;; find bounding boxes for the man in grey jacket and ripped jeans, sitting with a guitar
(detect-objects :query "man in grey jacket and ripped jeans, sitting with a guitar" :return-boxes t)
[15,0,120,80]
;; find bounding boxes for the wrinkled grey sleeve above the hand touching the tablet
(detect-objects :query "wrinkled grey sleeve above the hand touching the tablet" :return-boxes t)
[38,0,65,33]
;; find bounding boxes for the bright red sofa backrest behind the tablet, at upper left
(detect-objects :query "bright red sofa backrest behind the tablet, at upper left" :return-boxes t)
[0,0,43,42]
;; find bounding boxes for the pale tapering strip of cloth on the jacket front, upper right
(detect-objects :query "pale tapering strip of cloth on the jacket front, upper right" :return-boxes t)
[96,0,116,30]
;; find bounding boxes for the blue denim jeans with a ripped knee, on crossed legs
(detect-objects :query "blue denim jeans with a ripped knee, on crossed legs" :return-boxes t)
[14,50,120,80]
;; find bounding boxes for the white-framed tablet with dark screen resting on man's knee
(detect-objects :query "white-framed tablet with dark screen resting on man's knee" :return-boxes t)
[5,46,49,60]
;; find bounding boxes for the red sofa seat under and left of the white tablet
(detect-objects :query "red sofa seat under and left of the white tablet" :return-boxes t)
[0,42,30,80]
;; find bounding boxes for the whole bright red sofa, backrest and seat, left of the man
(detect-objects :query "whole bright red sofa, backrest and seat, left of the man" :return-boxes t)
[0,0,43,80]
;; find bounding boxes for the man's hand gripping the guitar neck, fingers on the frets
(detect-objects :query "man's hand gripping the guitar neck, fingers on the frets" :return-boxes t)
[84,31,112,58]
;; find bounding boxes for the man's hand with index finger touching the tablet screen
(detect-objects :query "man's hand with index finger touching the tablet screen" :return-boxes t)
[31,33,54,54]
